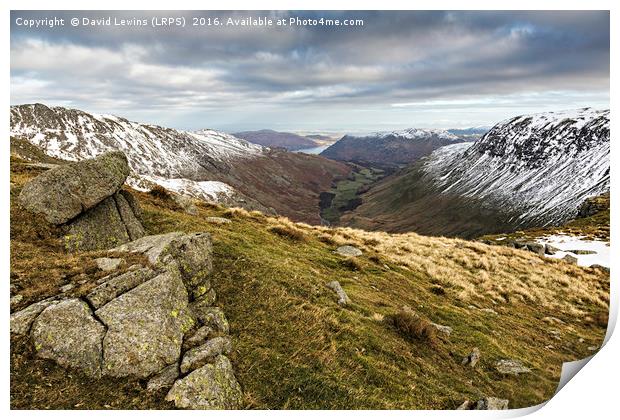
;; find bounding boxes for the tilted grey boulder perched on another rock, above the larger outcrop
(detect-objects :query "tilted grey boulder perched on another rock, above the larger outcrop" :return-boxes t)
[19,152,145,251]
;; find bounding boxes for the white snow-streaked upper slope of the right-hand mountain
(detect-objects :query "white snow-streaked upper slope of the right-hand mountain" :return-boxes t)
[423,108,610,225]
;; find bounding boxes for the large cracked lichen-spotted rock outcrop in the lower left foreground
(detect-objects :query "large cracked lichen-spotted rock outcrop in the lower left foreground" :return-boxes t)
[11,232,243,409]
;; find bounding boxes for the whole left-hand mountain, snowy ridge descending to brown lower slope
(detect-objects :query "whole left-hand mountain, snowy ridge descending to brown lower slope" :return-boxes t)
[10,104,349,223]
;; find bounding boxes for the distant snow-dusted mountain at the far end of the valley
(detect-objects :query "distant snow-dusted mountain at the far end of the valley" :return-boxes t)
[321,128,463,167]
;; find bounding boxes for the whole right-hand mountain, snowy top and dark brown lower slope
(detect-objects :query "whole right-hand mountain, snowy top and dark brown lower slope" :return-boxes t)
[341,108,610,237]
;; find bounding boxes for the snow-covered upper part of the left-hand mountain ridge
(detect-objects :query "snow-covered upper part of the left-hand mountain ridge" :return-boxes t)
[10,104,264,205]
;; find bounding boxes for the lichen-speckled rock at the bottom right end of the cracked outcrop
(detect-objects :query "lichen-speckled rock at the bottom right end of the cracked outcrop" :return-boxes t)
[166,356,243,410]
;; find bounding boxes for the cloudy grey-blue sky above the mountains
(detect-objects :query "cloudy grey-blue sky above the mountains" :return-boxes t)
[11,11,610,133]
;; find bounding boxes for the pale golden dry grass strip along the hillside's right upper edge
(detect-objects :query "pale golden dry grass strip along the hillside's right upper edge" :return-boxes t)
[308,226,609,315]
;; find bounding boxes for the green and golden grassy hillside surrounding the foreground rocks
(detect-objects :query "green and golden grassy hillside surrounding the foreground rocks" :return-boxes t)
[11,159,609,409]
